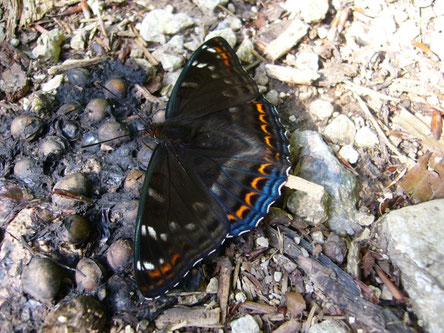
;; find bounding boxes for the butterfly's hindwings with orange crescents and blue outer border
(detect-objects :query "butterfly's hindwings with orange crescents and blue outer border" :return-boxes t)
[180,96,291,236]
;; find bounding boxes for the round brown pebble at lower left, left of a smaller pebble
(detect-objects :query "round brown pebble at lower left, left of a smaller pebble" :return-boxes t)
[22,258,62,300]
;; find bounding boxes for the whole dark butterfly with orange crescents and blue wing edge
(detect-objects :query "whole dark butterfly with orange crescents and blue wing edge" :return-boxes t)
[134,37,290,298]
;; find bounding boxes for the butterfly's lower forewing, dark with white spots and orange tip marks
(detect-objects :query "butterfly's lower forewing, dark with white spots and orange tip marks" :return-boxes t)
[134,143,229,298]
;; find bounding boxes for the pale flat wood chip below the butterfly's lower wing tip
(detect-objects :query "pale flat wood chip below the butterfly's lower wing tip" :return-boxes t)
[156,307,220,331]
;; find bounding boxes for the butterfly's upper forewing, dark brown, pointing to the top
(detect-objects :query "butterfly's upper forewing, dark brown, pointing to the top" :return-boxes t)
[166,37,259,119]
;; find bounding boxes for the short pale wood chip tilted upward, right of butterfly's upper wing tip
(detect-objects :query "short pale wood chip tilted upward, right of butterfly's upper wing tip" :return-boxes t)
[265,20,308,60]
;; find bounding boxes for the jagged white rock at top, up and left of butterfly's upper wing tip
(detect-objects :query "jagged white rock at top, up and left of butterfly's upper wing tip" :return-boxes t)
[136,6,194,44]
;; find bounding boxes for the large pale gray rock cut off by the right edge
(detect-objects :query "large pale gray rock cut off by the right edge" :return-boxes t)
[378,199,444,332]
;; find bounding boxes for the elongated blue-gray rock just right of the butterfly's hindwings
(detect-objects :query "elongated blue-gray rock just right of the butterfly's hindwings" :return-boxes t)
[290,131,362,235]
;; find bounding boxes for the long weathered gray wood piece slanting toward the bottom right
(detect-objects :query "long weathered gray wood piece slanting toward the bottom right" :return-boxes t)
[267,227,410,332]
